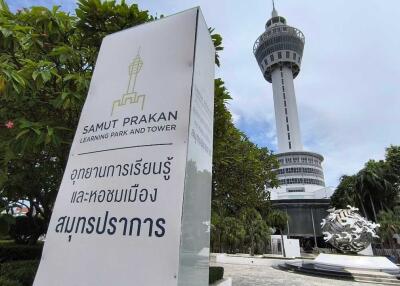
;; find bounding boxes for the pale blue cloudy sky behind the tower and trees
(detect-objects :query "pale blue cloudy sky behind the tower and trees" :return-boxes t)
[8,0,400,186]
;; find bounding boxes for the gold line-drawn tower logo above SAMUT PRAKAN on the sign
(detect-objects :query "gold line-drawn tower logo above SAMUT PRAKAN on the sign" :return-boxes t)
[111,48,146,116]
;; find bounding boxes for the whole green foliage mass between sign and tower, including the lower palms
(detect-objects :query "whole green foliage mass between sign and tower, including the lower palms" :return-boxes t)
[211,79,278,254]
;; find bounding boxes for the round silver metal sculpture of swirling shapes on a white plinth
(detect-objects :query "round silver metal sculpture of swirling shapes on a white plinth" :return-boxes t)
[321,206,379,253]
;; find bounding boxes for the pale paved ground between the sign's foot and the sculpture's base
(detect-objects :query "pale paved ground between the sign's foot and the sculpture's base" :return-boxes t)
[213,259,372,286]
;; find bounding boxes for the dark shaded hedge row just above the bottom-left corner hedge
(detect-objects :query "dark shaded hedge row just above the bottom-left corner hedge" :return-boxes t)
[0,243,43,262]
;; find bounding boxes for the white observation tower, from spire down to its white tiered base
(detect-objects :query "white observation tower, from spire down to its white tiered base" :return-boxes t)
[253,3,330,200]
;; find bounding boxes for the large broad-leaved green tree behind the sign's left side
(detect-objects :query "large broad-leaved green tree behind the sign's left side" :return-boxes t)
[0,0,153,243]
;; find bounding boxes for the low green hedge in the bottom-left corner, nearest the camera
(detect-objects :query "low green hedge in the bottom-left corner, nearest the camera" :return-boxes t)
[0,260,39,286]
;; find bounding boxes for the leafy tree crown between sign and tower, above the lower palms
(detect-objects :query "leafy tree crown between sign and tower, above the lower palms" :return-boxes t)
[212,79,278,216]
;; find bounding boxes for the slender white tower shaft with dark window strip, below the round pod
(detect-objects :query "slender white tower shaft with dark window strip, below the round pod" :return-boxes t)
[271,65,303,153]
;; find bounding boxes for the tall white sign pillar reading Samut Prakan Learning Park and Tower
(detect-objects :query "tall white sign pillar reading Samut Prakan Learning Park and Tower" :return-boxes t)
[34,8,214,286]
